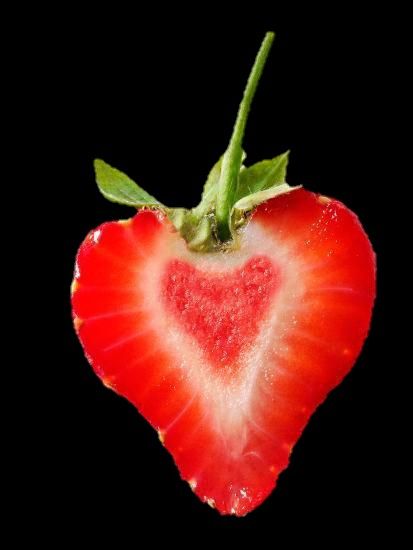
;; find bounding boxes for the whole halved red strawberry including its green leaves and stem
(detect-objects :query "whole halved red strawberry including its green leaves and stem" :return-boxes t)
[72,33,375,516]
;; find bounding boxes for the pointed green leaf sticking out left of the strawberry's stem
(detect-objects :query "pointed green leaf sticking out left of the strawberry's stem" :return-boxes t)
[94,159,162,208]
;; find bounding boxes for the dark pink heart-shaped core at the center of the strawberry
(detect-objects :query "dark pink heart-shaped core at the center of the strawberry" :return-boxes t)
[163,255,280,365]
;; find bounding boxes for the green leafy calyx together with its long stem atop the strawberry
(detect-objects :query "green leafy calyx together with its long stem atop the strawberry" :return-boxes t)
[94,32,298,252]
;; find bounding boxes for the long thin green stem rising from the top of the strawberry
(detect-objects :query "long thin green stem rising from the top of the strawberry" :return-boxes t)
[215,32,275,241]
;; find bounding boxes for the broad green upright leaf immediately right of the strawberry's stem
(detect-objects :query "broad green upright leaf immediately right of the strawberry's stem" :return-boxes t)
[235,151,289,202]
